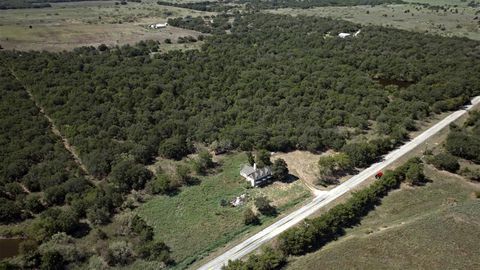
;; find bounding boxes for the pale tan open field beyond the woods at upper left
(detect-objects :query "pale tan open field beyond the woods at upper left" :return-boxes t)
[0,1,213,51]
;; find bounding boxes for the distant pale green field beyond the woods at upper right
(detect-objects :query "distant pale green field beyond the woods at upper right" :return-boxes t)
[268,0,480,40]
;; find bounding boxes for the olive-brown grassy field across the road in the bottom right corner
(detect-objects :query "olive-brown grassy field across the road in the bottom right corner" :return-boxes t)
[287,166,480,269]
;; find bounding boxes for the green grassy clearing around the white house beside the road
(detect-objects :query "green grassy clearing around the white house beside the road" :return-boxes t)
[138,153,311,268]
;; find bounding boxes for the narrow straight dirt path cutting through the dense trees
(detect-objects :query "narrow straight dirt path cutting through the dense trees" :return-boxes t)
[9,68,98,185]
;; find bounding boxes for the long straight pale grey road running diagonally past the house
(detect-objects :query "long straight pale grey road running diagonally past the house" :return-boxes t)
[199,96,480,270]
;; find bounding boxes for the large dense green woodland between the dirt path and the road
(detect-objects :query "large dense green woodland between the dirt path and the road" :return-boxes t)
[2,14,480,182]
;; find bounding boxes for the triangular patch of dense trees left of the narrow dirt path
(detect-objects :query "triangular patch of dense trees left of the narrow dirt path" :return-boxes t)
[0,65,89,223]
